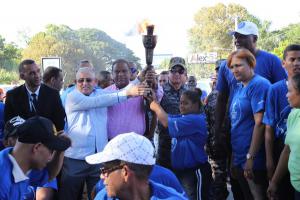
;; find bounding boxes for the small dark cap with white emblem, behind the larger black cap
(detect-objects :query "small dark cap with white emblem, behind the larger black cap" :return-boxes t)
[3,116,25,140]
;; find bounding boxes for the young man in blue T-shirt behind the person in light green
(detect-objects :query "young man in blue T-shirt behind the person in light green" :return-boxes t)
[263,44,300,199]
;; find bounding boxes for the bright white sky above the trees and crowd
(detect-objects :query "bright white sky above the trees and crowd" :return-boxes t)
[0,0,300,58]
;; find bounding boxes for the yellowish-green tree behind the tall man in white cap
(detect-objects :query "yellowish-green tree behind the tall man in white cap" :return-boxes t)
[189,3,270,57]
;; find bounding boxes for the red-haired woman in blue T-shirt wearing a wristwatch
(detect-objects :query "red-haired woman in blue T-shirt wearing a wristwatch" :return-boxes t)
[227,49,270,200]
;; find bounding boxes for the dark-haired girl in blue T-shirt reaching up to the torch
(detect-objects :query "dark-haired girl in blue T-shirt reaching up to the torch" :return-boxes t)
[147,91,212,200]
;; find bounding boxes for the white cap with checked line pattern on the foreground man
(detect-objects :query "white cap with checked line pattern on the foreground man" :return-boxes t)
[85,132,155,165]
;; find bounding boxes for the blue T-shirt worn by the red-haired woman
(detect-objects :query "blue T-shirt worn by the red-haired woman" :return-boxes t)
[229,75,270,169]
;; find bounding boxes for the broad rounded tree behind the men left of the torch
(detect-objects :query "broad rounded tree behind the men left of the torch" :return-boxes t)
[22,24,139,84]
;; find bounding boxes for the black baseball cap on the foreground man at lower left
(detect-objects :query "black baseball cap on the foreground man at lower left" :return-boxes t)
[17,116,71,151]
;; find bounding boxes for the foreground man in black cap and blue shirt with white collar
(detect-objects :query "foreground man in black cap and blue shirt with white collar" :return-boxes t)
[0,116,71,200]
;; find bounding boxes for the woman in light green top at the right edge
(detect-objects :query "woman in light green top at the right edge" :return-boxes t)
[268,72,300,200]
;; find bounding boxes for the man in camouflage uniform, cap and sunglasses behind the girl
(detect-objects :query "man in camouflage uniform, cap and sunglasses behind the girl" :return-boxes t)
[157,57,186,169]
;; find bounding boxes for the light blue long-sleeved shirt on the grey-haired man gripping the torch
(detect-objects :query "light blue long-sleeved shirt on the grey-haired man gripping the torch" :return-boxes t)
[65,89,127,160]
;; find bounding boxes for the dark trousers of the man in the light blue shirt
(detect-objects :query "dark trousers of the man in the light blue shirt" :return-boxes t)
[58,157,100,200]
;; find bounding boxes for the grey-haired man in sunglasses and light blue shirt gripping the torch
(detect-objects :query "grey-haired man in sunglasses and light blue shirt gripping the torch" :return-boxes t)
[59,67,146,199]
